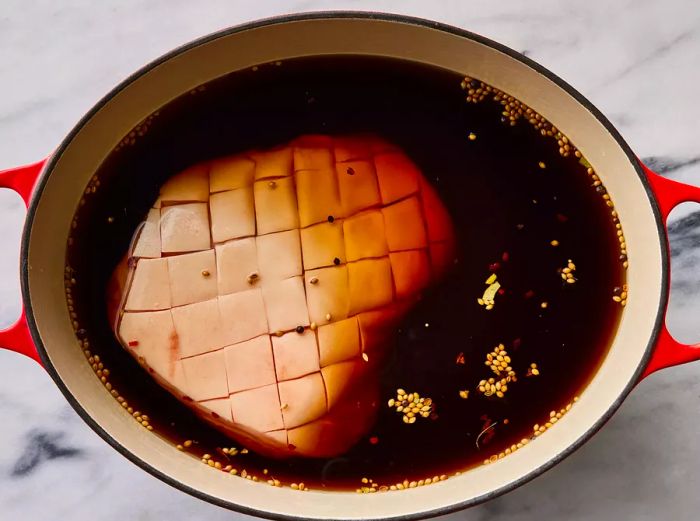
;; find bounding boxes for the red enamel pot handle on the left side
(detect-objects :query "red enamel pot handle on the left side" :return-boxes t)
[0,159,46,364]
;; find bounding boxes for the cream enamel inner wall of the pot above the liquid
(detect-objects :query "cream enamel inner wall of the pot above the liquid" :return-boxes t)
[27,14,662,519]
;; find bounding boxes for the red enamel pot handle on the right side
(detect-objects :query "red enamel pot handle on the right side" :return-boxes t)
[642,160,700,378]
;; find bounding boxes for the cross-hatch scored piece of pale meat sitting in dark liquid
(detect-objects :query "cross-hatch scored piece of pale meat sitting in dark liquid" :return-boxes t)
[107,136,454,457]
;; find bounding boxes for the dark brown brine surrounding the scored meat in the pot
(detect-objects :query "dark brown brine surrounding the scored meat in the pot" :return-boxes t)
[67,57,626,490]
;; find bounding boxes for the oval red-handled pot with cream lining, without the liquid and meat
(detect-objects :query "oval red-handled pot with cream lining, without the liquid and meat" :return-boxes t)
[0,12,700,519]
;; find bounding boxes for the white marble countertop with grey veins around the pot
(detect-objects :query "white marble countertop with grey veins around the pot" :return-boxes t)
[0,0,700,521]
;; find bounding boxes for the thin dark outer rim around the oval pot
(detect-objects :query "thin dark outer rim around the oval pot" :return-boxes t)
[20,10,669,521]
